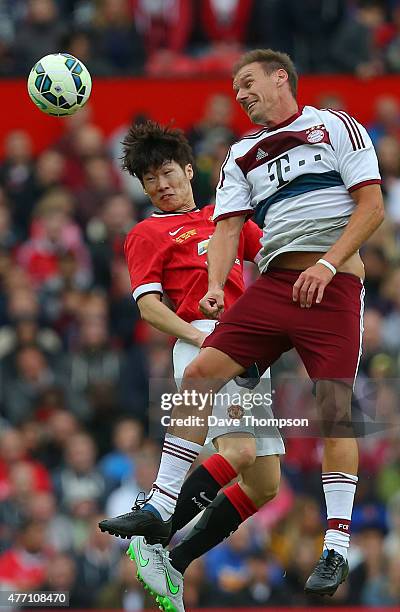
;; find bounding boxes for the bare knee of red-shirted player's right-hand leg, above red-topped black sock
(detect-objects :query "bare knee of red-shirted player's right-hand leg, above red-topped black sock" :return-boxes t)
[239,455,281,506]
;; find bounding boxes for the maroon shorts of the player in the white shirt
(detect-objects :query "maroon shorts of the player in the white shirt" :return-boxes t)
[203,268,364,383]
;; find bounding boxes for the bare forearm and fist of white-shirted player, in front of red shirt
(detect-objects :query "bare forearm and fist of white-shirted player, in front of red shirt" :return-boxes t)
[199,215,245,319]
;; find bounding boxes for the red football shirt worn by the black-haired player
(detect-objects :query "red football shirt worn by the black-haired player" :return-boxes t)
[125,206,262,322]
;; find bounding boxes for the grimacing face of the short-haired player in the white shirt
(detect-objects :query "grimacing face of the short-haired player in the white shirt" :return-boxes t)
[233,62,287,125]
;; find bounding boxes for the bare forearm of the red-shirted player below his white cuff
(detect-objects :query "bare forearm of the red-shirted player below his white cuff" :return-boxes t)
[137,293,207,347]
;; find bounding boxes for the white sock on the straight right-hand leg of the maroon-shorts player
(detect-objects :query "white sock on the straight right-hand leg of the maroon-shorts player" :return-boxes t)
[322,472,358,559]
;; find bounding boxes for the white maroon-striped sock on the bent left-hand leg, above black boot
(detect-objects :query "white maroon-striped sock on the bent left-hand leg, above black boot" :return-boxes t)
[148,434,203,521]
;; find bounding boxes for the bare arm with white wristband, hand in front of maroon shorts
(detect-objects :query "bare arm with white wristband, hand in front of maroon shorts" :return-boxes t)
[293,180,384,308]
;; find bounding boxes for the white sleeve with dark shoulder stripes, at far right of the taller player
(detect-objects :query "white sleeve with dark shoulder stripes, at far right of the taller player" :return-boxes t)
[329,110,381,192]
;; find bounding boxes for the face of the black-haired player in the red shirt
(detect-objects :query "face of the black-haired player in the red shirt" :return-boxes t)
[143,160,194,212]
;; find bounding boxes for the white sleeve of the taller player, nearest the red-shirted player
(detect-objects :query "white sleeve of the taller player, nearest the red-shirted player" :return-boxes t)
[213,147,253,222]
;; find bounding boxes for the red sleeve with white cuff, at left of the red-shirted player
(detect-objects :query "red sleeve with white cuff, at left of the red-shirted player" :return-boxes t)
[124,234,165,301]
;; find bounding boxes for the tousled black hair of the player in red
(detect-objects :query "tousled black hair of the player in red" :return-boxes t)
[122,121,194,183]
